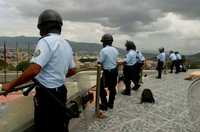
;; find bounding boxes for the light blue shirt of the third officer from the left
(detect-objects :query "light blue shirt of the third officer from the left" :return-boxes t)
[125,49,137,66]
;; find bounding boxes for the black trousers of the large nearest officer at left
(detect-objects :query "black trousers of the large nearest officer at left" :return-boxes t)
[34,85,68,132]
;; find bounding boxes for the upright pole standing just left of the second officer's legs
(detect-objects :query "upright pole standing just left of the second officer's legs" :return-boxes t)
[95,65,101,116]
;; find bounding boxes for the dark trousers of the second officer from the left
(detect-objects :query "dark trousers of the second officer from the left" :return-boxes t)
[100,68,118,107]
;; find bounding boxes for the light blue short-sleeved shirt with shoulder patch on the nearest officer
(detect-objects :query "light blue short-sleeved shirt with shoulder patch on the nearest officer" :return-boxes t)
[30,33,75,88]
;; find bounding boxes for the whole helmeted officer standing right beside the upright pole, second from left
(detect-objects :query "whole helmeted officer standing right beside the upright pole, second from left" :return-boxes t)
[98,34,119,111]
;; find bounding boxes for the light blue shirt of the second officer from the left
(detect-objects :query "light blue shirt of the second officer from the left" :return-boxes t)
[98,45,119,70]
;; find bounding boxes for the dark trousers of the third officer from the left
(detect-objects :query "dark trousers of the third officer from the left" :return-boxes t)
[123,65,140,92]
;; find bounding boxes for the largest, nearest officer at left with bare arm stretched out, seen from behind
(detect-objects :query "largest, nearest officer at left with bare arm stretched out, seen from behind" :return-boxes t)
[3,9,75,132]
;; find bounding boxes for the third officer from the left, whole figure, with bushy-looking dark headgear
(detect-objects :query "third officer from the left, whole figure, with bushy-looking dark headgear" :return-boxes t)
[122,41,140,96]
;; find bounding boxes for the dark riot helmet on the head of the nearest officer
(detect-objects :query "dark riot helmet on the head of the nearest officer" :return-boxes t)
[37,9,63,35]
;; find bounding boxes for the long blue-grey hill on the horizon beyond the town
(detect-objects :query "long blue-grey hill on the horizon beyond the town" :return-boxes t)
[0,36,156,58]
